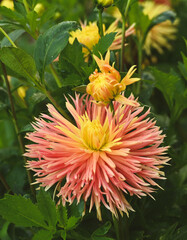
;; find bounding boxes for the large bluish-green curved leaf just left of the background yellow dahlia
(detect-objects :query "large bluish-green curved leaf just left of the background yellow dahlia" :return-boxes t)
[34,21,77,79]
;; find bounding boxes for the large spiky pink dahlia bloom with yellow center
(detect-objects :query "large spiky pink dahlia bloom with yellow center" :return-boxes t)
[25,95,169,220]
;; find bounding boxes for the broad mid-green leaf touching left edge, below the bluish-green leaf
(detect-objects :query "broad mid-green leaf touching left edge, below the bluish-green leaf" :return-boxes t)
[0,47,36,84]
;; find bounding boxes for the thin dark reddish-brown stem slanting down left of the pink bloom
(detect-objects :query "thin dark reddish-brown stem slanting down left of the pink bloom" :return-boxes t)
[1,62,36,199]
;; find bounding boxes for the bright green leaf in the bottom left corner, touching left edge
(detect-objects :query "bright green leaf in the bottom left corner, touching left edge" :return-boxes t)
[0,194,48,229]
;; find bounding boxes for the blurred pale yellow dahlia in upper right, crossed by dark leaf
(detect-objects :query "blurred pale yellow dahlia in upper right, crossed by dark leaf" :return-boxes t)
[141,1,178,55]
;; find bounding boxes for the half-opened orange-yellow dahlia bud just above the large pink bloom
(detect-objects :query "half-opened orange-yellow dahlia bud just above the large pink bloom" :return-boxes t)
[86,51,140,106]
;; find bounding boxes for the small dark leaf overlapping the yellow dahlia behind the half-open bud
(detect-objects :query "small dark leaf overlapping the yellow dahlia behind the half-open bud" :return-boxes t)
[93,32,116,57]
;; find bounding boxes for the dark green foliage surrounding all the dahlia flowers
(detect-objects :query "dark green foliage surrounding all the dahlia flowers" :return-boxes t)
[0,0,187,240]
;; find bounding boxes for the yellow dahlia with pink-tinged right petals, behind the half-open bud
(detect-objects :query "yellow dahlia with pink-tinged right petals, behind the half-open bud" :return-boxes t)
[69,20,134,57]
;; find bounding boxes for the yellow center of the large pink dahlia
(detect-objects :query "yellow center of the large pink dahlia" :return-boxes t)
[81,116,108,150]
